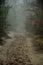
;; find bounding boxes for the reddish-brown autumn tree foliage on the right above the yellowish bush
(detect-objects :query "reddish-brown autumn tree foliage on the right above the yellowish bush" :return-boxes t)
[30,0,43,37]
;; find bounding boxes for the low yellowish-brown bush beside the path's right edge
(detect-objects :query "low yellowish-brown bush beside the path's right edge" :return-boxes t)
[33,36,43,49]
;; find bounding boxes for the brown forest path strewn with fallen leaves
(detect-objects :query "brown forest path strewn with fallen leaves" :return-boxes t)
[0,32,43,65]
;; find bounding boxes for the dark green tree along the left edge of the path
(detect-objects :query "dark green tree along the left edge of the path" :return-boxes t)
[0,0,9,44]
